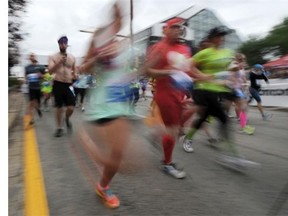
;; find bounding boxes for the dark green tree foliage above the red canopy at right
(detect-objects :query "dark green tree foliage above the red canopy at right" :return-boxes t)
[238,17,288,65]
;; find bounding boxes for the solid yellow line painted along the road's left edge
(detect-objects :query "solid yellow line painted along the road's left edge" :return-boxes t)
[23,115,49,216]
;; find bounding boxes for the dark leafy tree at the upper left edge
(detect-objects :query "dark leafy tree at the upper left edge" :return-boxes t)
[8,0,28,76]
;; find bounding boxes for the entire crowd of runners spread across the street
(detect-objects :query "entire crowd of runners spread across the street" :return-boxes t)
[25,0,271,208]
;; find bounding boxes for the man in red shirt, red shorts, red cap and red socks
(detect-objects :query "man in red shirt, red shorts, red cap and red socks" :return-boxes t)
[145,17,212,179]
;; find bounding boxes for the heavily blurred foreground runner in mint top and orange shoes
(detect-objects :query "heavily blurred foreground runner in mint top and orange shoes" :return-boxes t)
[79,2,132,208]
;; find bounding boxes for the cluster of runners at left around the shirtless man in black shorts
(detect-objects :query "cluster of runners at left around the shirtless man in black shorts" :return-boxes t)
[21,39,96,137]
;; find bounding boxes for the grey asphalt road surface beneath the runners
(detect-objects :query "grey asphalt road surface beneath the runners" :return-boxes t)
[9,96,288,216]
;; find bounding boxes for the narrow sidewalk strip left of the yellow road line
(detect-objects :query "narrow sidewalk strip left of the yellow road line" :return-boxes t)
[8,91,25,216]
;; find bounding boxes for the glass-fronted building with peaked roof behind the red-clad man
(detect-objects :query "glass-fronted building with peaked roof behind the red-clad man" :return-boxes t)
[133,6,242,58]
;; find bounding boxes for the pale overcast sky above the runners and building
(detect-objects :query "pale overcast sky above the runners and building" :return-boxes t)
[16,0,288,57]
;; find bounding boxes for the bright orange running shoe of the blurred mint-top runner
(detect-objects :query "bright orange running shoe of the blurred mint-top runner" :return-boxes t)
[96,183,120,208]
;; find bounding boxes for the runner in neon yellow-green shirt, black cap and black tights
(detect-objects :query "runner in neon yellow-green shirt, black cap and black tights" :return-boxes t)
[183,27,254,167]
